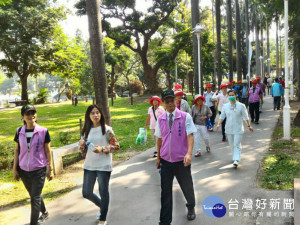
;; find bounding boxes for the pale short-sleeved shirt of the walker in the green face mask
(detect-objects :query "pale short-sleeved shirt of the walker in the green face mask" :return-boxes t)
[220,102,249,134]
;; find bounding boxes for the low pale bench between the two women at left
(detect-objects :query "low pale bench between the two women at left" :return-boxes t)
[51,143,80,175]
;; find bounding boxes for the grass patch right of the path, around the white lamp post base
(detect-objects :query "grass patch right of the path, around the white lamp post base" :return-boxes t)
[260,127,300,190]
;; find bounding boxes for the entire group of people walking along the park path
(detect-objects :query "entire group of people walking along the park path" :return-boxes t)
[13,77,283,225]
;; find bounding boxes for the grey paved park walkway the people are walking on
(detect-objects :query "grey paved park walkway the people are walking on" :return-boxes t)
[2,97,293,225]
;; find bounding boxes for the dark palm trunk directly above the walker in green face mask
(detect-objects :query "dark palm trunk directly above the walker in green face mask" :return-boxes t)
[227,0,233,81]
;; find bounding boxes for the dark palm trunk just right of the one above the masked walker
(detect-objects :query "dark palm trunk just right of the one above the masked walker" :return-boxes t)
[235,0,242,80]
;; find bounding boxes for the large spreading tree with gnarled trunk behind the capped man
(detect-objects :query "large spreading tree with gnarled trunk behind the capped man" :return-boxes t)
[77,0,182,93]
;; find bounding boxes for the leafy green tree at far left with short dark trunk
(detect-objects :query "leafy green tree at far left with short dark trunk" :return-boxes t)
[0,0,76,100]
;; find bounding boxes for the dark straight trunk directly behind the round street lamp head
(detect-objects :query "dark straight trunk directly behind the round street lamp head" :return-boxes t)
[191,0,200,93]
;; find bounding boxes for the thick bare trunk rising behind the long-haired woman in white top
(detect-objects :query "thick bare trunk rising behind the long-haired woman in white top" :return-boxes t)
[86,0,111,125]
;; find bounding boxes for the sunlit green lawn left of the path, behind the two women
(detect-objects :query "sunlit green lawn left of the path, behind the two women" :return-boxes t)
[0,97,154,208]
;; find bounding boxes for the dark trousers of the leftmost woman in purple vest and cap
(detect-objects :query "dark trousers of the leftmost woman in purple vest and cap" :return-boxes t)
[19,167,46,225]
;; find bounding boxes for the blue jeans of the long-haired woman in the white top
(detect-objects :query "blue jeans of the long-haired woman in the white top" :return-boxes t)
[82,169,111,221]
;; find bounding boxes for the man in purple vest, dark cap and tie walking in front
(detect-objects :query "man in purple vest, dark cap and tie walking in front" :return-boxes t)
[154,90,197,225]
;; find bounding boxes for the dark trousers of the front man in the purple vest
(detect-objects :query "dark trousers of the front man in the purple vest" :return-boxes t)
[159,159,196,225]
